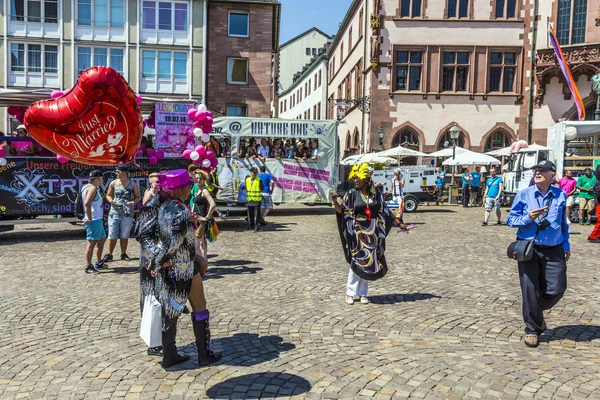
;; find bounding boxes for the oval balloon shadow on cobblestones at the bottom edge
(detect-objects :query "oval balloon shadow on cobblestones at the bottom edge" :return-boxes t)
[206,372,311,399]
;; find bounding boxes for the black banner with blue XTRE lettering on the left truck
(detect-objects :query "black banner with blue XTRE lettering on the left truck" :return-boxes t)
[0,157,189,215]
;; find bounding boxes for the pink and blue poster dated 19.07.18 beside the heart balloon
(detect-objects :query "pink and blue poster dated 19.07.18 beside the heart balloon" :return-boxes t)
[154,101,196,158]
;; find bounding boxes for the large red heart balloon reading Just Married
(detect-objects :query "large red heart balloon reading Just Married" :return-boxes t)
[24,67,143,165]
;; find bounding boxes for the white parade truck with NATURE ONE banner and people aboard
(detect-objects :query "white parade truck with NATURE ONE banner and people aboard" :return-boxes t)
[211,117,339,208]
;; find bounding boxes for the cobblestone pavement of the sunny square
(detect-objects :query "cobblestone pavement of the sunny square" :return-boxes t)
[0,206,600,399]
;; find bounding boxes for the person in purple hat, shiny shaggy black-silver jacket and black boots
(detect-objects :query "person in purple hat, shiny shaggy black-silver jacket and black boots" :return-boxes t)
[138,169,221,368]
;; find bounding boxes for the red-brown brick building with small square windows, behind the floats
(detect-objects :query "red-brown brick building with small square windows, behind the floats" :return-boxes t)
[205,0,281,118]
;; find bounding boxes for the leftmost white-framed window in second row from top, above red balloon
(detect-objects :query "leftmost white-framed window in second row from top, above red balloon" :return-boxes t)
[10,43,58,75]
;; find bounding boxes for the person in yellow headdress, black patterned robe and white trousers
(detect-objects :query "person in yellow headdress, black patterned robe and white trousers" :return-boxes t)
[331,163,406,304]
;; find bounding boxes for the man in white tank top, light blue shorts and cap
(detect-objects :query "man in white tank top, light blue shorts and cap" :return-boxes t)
[81,170,106,275]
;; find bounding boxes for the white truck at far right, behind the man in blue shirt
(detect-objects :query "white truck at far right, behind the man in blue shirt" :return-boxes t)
[503,121,600,204]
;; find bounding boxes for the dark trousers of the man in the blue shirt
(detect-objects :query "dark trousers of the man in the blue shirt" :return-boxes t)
[519,244,567,335]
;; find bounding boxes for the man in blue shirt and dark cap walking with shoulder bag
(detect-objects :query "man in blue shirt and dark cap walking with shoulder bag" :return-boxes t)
[506,160,571,347]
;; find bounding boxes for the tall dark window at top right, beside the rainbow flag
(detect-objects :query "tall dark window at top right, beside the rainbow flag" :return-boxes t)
[556,0,587,45]
